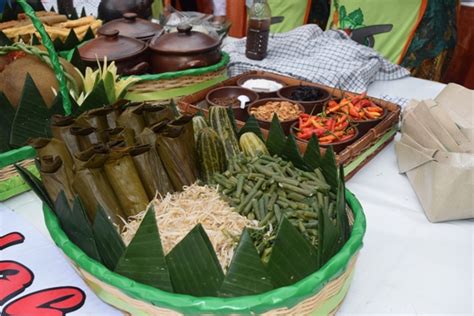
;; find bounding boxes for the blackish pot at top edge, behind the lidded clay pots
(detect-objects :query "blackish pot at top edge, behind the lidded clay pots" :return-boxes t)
[99,0,153,22]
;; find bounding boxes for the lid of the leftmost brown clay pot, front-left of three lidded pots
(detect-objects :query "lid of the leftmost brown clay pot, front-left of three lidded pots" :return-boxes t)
[79,29,146,62]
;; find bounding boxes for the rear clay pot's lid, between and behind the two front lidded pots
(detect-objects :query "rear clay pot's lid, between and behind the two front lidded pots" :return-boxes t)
[99,12,163,40]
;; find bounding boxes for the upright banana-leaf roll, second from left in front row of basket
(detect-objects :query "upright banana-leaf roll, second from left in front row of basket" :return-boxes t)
[72,145,126,227]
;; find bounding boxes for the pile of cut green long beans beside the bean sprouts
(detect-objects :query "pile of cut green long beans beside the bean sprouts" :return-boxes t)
[213,155,336,261]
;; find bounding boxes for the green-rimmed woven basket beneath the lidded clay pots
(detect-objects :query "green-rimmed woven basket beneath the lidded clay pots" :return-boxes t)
[125,52,230,102]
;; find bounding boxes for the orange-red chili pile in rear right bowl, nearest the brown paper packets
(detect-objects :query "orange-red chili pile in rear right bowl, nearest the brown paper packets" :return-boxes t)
[325,93,384,121]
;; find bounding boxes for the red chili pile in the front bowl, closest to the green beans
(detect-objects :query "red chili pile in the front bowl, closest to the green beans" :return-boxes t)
[296,113,356,145]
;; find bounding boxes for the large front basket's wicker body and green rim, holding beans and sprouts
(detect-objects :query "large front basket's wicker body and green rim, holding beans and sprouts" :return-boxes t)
[43,191,366,315]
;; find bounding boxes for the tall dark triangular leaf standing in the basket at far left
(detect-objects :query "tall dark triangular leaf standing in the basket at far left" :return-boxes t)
[10,74,51,147]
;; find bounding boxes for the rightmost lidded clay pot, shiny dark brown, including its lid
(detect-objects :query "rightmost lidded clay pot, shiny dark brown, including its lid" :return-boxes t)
[149,24,221,73]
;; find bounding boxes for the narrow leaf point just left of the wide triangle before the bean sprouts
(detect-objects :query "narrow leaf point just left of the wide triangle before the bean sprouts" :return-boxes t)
[92,205,125,271]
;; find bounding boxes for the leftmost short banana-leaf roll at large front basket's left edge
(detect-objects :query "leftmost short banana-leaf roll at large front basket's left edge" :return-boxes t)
[37,156,74,207]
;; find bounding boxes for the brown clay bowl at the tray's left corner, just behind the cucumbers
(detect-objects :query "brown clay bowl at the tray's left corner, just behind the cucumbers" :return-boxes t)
[206,86,259,122]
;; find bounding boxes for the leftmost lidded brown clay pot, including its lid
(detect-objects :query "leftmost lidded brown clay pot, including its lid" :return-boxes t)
[79,30,149,75]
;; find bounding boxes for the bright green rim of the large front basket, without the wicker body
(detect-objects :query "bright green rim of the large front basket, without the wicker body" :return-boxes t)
[43,189,366,314]
